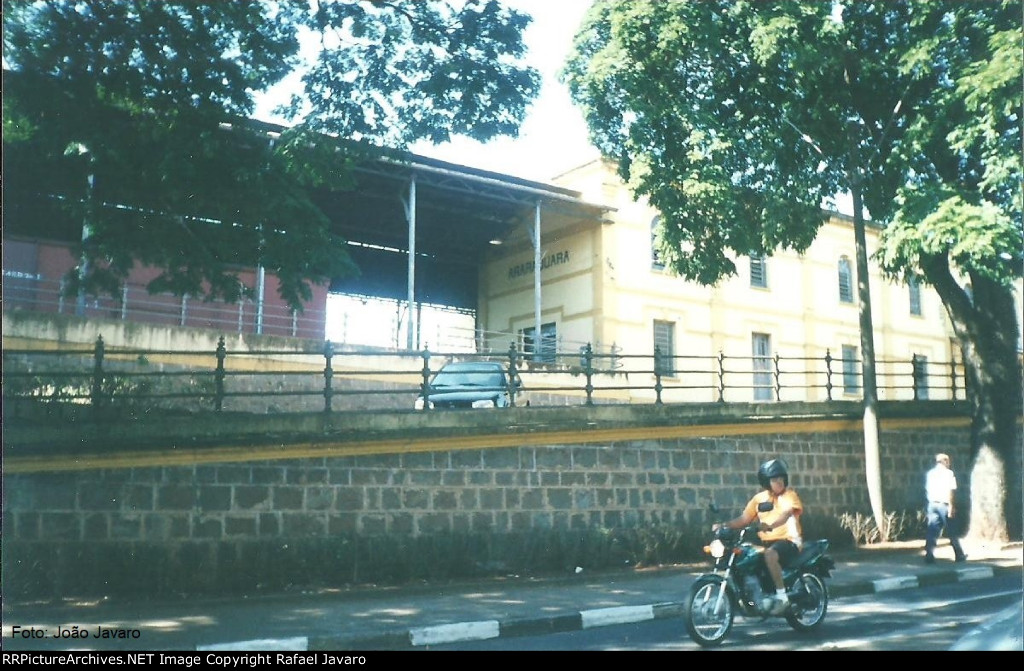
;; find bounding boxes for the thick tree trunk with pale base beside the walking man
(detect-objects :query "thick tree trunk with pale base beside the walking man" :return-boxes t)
[923,257,1024,541]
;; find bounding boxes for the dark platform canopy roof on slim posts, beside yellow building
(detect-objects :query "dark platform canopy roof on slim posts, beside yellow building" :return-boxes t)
[316,143,611,308]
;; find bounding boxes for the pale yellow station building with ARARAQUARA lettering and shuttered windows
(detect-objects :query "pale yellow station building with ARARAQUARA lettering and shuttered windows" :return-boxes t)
[478,161,1021,401]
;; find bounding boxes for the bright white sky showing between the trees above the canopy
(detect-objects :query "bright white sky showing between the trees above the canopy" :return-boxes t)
[255,0,598,181]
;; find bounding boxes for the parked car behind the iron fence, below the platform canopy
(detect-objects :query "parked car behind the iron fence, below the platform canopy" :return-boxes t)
[415,362,529,410]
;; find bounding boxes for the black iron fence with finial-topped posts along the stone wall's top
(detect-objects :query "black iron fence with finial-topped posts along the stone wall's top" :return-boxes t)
[3,338,966,418]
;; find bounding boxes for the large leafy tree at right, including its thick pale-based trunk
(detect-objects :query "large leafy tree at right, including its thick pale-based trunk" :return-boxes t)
[563,1,1024,539]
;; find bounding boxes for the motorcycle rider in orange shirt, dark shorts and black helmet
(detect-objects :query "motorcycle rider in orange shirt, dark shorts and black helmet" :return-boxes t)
[712,459,804,615]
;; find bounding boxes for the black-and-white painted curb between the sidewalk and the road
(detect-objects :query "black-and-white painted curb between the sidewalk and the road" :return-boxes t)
[196,565,1020,652]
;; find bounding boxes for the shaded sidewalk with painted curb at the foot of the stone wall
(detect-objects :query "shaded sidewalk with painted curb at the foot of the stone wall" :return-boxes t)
[2,541,1024,651]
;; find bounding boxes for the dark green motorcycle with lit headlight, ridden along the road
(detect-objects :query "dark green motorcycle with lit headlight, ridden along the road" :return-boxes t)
[683,502,836,647]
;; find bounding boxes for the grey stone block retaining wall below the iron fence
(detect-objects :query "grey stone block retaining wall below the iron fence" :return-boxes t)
[3,411,983,596]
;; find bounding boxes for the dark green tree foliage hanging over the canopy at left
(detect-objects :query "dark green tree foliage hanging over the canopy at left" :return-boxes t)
[3,0,540,309]
